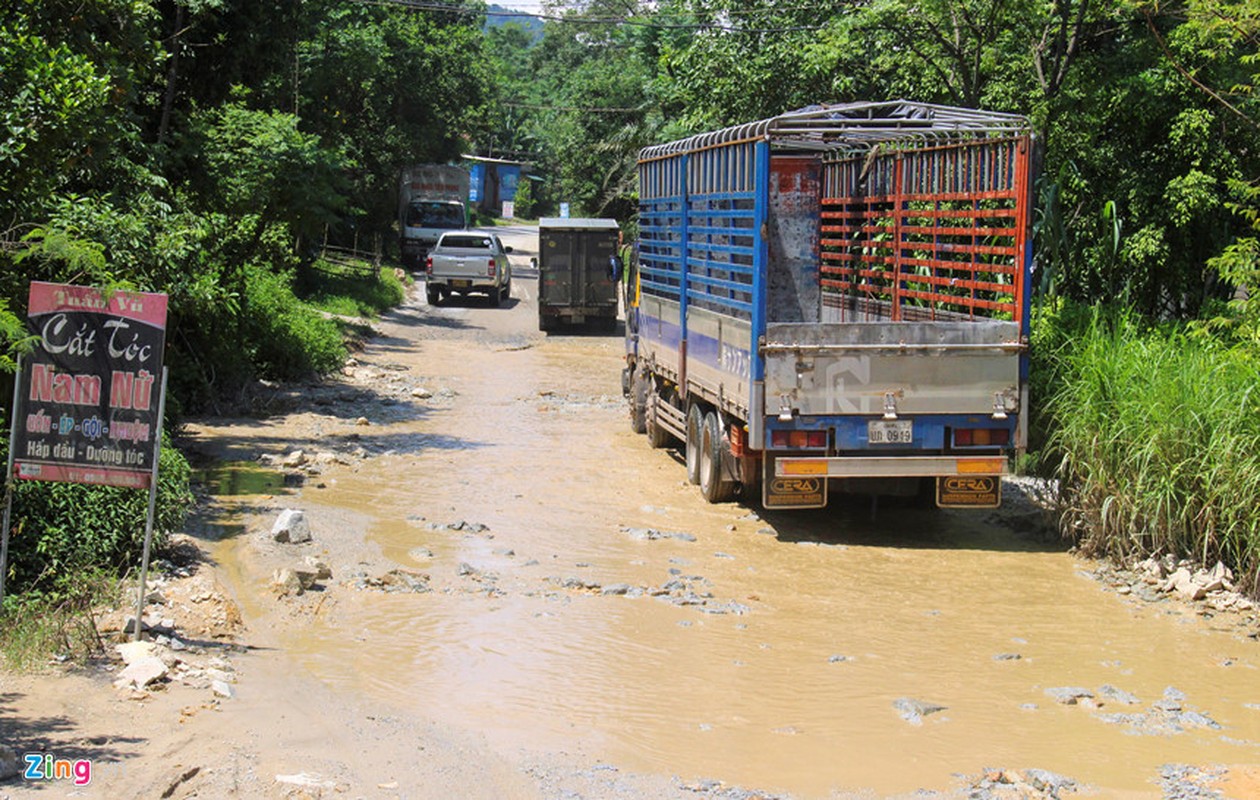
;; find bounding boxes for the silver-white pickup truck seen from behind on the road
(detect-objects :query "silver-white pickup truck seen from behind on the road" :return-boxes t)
[425,231,512,306]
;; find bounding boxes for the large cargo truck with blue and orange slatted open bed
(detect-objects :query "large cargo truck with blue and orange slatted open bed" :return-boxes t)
[622,101,1033,509]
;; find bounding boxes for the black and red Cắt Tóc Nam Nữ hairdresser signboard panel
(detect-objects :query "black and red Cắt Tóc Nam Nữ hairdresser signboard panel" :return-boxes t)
[11,282,166,489]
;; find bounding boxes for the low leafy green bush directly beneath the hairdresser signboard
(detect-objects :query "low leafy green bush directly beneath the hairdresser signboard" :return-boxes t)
[5,445,193,607]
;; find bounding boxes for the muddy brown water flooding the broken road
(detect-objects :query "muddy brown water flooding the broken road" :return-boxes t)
[199,228,1260,797]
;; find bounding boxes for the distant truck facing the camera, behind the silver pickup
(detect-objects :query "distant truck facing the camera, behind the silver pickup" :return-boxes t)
[398,164,469,271]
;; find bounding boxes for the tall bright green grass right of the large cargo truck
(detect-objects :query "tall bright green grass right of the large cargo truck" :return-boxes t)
[1047,315,1260,586]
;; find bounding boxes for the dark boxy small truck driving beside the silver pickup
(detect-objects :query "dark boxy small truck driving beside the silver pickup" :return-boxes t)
[538,217,621,331]
